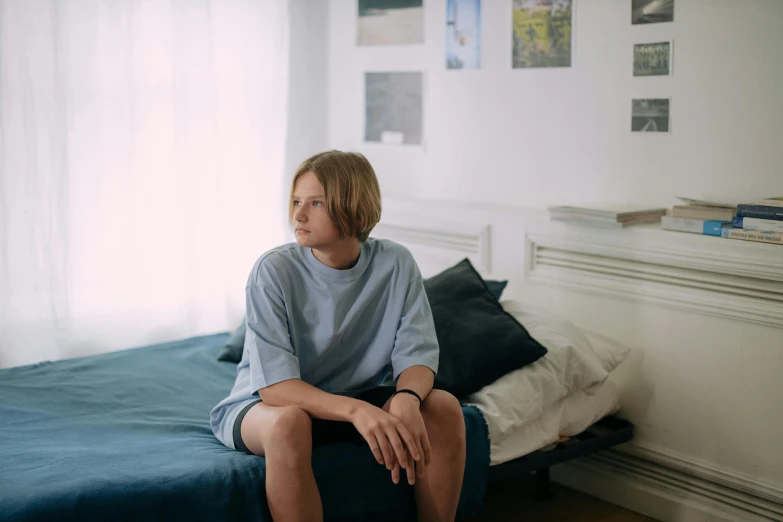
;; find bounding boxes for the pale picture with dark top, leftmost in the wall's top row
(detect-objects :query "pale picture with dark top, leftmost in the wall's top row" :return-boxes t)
[357,0,424,45]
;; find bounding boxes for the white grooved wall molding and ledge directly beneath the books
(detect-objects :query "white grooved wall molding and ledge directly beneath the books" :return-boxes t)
[525,224,783,328]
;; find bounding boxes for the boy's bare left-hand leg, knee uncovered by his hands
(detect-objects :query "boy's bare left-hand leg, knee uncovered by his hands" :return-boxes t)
[242,403,323,522]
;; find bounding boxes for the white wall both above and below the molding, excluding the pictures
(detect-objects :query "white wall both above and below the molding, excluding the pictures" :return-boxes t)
[327,0,783,520]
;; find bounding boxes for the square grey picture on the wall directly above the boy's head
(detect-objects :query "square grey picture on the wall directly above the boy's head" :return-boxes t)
[364,72,423,145]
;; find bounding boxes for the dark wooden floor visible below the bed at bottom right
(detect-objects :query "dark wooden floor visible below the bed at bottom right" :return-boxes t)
[468,481,656,522]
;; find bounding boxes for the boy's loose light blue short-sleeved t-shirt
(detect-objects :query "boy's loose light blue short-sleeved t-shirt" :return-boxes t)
[210,238,439,448]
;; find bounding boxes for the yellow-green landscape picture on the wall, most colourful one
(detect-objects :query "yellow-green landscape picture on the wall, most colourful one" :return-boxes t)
[512,0,573,69]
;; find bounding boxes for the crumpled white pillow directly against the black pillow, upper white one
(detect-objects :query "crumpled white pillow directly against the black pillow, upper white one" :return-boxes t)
[467,300,628,442]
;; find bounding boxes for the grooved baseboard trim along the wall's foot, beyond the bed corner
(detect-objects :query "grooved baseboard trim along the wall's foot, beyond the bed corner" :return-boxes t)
[552,446,783,522]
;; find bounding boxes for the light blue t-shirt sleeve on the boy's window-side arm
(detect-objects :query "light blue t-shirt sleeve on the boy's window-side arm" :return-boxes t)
[245,266,300,395]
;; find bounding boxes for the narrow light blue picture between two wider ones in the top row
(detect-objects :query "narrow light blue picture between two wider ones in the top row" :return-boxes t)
[446,0,481,69]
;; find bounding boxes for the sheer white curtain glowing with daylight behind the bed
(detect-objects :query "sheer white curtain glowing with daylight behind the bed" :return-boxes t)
[0,0,288,367]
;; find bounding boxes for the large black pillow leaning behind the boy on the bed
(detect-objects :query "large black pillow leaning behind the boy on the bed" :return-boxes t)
[424,258,547,399]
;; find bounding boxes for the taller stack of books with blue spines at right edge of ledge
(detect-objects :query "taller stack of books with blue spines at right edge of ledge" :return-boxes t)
[661,197,783,245]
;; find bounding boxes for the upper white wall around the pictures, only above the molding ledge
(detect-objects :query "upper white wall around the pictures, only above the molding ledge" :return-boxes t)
[328,0,783,207]
